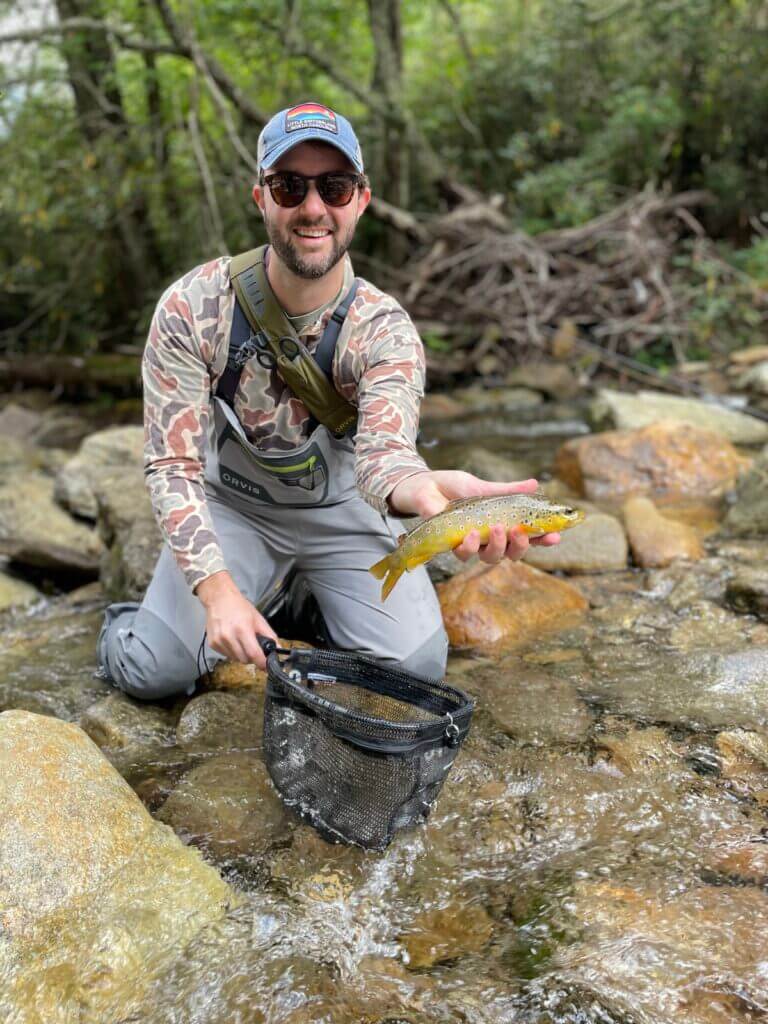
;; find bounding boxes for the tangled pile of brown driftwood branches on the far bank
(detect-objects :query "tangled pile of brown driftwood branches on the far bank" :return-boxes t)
[370,191,711,376]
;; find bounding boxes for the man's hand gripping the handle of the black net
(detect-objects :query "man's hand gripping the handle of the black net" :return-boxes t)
[195,571,278,669]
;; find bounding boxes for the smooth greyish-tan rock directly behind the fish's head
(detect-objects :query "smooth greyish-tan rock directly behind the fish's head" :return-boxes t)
[524,512,629,572]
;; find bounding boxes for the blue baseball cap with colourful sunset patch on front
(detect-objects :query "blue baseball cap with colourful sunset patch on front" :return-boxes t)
[256,102,362,174]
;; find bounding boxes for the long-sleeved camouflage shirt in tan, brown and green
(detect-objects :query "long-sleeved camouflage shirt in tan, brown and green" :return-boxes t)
[142,257,427,588]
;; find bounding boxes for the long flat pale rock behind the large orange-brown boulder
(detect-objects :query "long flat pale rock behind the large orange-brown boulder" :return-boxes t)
[590,388,768,444]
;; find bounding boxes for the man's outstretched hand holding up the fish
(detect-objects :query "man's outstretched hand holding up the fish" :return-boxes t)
[389,470,560,565]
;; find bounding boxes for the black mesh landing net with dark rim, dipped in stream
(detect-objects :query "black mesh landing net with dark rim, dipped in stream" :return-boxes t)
[262,641,474,850]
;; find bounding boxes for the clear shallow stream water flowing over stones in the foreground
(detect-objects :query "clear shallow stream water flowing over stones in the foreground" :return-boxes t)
[0,403,768,1024]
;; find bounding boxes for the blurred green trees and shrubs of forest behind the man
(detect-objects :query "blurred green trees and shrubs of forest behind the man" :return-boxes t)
[0,0,768,380]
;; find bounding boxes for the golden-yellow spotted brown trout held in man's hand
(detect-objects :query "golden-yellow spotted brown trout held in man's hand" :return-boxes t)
[369,494,584,601]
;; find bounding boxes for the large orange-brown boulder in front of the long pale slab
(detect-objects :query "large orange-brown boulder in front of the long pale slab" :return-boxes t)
[554,420,744,501]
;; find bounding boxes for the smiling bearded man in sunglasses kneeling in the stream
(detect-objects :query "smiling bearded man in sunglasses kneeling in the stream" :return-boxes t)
[98,103,559,699]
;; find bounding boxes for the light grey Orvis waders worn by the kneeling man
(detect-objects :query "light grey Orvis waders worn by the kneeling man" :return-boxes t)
[97,292,447,699]
